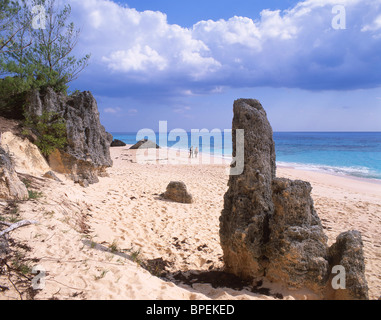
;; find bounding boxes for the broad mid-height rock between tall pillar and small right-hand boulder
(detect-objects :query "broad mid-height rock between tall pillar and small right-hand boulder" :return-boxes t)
[266,178,329,296]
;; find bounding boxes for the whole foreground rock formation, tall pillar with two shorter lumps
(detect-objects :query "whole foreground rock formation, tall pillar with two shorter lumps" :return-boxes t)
[220,99,367,299]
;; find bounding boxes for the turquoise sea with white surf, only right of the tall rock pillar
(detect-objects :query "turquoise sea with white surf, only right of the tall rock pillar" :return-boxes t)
[274,132,381,179]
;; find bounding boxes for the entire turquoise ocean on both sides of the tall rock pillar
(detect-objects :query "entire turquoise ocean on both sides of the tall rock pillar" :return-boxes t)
[112,130,381,181]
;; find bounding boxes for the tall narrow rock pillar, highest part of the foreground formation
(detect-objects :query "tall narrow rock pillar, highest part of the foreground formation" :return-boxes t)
[220,99,276,278]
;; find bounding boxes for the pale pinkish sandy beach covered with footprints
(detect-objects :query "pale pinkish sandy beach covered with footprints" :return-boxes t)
[0,146,381,300]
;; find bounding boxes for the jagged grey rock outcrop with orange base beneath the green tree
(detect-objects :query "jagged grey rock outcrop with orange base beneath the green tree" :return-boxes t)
[26,88,112,185]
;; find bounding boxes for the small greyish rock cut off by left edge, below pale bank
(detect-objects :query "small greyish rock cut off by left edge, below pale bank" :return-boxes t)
[0,147,28,200]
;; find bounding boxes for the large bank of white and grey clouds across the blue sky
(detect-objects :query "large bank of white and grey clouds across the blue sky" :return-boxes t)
[70,0,381,96]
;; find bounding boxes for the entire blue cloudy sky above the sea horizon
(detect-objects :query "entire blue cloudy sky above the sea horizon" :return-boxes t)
[65,0,381,132]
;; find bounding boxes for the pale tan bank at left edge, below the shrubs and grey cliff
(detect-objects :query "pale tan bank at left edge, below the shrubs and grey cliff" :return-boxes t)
[1,132,50,176]
